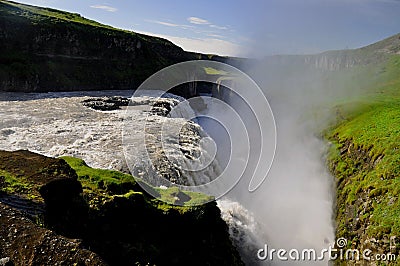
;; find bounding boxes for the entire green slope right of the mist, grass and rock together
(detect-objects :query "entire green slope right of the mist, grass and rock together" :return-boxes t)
[327,48,400,260]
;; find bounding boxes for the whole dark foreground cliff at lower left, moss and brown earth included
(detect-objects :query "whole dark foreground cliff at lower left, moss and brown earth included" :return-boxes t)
[0,151,242,265]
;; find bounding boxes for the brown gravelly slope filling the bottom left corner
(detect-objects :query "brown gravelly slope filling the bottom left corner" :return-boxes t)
[0,203,107,266]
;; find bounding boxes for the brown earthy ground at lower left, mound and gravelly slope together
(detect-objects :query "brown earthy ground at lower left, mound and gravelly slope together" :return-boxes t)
[0,150,106,265]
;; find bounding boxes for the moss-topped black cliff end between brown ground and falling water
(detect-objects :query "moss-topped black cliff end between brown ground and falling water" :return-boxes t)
[62,157,242,265]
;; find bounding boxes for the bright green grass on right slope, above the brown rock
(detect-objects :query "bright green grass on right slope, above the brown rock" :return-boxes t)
[330,101,400,236]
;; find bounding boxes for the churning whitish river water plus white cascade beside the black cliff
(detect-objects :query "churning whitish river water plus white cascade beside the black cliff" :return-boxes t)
[0,91,257,264]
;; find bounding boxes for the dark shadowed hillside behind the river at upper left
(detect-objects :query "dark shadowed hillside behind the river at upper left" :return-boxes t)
[0,0,238,92]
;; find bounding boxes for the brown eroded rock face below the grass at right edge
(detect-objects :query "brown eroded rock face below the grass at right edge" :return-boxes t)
[329,139,399,265]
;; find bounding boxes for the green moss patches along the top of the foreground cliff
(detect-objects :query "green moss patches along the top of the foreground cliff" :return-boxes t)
[0,156,213,213]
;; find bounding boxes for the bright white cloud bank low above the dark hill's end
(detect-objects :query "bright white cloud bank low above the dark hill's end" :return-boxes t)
[136,31,244,56]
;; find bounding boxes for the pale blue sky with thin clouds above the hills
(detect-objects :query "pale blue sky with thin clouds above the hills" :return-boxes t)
[11,0,400,56]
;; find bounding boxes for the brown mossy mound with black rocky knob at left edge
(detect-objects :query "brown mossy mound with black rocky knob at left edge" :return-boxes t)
[0,150,88,236]
